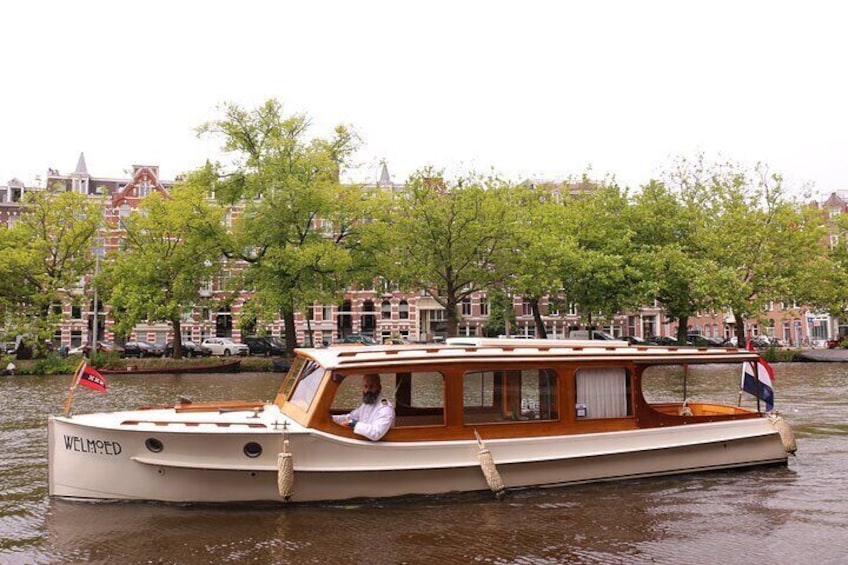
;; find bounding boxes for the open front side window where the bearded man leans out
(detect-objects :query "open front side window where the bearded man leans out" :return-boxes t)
[331,371,445,428]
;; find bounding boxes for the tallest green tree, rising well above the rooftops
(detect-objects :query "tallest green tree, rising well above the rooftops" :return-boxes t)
[199,100,374,351]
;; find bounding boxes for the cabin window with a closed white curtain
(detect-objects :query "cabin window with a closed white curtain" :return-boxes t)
[574,368,633,420]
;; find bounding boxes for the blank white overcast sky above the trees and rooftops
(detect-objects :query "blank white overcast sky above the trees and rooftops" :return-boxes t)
[0,0,848,200]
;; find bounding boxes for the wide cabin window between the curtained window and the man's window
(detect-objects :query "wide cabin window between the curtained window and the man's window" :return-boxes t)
[462,369,559,424]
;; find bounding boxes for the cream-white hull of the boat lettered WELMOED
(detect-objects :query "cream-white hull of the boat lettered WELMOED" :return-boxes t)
[48,405,787,502]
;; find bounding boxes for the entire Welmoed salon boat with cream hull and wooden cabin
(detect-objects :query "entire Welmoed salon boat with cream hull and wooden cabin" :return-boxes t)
[48,338,794,503]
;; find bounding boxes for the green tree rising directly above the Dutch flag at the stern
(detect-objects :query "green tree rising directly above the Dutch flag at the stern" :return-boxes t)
[660,156,826,343]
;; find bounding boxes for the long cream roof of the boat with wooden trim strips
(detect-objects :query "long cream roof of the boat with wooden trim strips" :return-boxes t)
[296,337,759,369]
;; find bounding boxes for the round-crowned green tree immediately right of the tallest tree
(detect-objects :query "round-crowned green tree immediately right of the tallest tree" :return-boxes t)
[388,170,511,336]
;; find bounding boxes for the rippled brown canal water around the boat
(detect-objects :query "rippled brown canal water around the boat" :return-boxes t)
[0,363,848,565]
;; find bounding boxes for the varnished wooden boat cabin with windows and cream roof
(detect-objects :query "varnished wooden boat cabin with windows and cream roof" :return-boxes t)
[275,338,758,441]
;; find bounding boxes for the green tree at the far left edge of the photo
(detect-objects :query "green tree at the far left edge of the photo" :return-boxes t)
[0,187,103,352]
